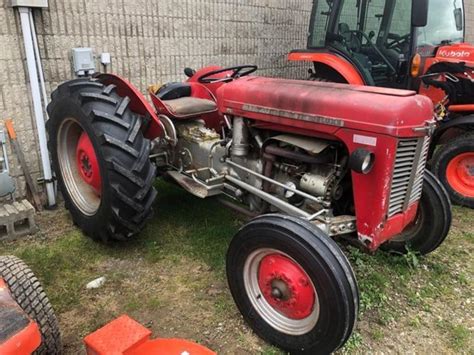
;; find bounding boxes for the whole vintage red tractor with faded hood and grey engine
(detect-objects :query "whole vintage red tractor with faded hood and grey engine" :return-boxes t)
[47,65,451,354]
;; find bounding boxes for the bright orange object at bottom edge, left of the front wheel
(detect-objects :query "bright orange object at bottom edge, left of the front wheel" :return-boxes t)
[84,315,216,355]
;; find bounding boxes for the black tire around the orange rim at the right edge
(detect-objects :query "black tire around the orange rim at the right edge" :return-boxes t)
[431,132,474,208]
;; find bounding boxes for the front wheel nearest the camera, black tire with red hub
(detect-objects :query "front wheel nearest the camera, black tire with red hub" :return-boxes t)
[227,215,359,354]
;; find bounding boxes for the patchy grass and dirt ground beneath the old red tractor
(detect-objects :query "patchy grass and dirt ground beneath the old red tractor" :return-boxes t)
[0,184,474,354]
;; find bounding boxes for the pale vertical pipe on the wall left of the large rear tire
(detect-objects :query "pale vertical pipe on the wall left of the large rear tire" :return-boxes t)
[18,7,56,208]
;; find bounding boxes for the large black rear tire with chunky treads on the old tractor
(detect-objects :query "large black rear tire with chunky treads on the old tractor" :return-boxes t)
[47,79,156,241]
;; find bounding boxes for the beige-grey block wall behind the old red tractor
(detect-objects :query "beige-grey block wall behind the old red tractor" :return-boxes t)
[0,0,474,200]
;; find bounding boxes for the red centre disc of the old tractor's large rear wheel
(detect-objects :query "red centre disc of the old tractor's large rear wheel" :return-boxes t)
[76,132,102,195]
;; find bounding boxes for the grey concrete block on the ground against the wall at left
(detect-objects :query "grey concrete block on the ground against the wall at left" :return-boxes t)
[0,200,38,240]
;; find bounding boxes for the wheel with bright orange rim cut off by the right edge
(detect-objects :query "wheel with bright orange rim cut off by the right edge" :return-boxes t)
[432,133,474,208]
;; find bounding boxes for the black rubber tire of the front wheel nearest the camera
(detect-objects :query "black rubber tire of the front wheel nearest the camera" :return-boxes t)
[227,215,359,354]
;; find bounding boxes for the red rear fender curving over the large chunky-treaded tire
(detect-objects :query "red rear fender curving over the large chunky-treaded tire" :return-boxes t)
[95,74,165,140]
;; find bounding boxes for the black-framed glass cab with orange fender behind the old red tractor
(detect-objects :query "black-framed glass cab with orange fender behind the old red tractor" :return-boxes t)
[290,0,464,88]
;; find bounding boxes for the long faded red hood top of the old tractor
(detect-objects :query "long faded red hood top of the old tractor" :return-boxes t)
[217,77,433,137]
